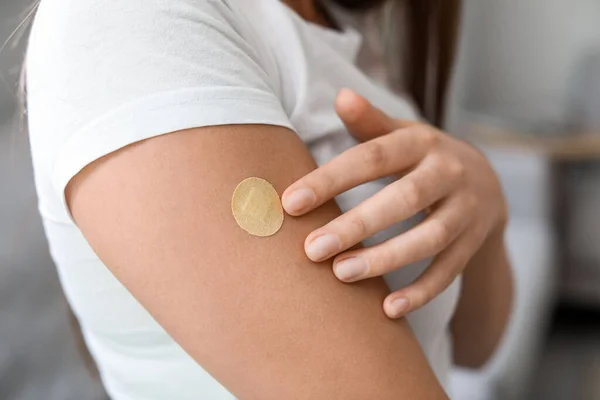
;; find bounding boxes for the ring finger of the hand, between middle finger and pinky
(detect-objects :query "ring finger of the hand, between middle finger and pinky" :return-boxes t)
[333,194,471,282]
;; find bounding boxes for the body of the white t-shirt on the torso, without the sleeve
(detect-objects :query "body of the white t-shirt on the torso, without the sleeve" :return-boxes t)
[27,0,460,400]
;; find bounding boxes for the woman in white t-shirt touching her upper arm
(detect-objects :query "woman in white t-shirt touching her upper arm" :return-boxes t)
[26,0,511,400]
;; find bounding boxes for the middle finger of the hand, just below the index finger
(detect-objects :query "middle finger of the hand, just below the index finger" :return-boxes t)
[305,153,459,262]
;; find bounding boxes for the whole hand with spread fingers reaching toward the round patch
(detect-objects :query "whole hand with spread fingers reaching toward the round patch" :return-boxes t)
[282,90,507,318]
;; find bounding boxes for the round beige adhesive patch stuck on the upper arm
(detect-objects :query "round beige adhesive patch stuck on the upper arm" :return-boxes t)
[231,178,283,237]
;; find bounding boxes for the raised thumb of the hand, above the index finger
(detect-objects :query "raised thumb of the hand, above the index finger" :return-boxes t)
[335,89,418,142]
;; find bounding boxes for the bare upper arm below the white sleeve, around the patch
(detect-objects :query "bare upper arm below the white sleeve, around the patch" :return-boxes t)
[66,125,446,399]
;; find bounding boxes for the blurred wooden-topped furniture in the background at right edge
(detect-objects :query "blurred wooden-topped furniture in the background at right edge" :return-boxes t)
[465,123,600,308]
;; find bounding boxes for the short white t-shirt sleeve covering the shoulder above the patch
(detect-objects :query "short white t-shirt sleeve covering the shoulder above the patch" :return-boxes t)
[26,0,292,217]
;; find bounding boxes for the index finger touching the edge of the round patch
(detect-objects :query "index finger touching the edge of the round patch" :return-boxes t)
[282,126,435,216]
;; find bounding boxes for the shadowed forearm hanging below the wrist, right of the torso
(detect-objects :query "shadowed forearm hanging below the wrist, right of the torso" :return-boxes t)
[452,223,513,368]
